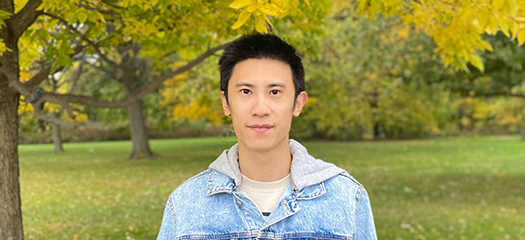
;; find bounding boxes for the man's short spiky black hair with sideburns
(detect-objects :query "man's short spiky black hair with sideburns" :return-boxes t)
[219,33,305,103]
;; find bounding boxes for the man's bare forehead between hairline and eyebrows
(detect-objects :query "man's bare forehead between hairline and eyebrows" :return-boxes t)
[228,58,293,86]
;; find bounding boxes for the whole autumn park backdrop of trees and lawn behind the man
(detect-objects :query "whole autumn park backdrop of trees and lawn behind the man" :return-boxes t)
[0,0,525,240]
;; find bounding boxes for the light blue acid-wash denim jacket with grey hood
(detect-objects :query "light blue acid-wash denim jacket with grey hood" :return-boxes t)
[157,140,377,240]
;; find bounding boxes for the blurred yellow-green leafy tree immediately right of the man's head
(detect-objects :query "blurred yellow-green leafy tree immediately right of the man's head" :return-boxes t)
[284,10,455,140]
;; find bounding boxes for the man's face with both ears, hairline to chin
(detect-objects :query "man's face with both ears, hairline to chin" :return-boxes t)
[221,59,307,151]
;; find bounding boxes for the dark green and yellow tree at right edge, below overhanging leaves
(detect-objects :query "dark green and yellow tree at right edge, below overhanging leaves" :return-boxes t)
[443,33,525,137]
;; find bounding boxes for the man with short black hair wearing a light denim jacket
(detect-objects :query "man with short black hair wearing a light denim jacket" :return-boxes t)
[158,34,377,239]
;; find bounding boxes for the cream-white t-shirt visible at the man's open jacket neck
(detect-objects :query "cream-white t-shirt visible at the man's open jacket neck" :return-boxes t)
[239,174,290,219]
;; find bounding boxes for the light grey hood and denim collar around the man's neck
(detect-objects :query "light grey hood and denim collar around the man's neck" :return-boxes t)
[206,139,345,199]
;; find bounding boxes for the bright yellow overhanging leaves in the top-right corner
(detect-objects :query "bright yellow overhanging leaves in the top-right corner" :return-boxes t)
[357,0,525,71]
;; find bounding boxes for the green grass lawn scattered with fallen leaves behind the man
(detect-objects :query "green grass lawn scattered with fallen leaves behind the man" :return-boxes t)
[19,136,525,240]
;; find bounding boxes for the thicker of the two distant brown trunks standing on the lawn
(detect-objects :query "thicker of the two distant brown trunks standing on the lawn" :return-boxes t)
[128,100,156,159]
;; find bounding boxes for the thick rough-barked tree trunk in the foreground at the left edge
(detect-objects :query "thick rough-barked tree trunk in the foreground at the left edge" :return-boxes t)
[0,56,24,240]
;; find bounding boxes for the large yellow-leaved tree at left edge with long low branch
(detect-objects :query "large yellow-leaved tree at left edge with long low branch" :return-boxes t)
[0,0,324,239]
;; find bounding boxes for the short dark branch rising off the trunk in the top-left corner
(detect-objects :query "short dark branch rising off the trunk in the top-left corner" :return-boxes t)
[9,0,42,39]
